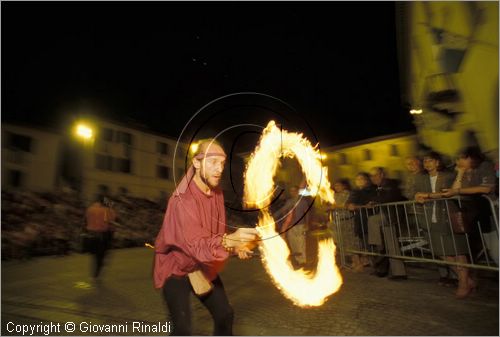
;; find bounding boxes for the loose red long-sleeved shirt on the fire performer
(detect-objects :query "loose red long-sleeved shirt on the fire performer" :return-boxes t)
[153,180,229,288]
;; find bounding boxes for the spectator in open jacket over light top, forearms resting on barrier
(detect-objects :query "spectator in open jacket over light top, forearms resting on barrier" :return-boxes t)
[415,151,476,298]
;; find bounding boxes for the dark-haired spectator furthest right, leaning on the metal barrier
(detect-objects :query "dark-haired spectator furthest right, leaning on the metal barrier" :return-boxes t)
[443,147,498,266]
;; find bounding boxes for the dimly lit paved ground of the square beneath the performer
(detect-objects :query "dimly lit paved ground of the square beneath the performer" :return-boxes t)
[2,248,499,336]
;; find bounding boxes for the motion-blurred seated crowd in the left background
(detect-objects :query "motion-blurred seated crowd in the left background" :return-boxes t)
[2,191,165,260]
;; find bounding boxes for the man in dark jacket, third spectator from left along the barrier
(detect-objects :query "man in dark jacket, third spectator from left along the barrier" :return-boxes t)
[368,167,407,280]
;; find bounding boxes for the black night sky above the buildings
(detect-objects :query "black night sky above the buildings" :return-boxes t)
[2,2,412,146]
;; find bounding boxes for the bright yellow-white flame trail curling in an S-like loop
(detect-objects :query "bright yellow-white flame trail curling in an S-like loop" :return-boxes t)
[245,121,342,307]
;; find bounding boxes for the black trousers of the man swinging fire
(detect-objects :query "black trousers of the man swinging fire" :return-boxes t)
[163,276,234,336]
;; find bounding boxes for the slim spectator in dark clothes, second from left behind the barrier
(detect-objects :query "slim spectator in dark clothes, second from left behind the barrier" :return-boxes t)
[346,172,375,272]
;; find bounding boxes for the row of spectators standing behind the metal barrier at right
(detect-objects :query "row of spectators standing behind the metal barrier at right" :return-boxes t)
[334,147,498,298]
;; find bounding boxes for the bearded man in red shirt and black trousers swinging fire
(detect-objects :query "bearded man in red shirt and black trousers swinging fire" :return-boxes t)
[153,139,257,335]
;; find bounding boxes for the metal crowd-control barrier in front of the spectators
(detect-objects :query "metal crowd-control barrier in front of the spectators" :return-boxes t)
[329,196,499,271]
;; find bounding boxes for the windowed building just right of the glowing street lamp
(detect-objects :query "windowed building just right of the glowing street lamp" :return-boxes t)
[68,120,187,201]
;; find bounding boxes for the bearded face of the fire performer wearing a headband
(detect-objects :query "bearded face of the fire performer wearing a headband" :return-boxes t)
[195,143,226,188]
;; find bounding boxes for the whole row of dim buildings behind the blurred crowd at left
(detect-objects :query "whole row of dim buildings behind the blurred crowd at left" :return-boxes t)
[2,118,188,202]
